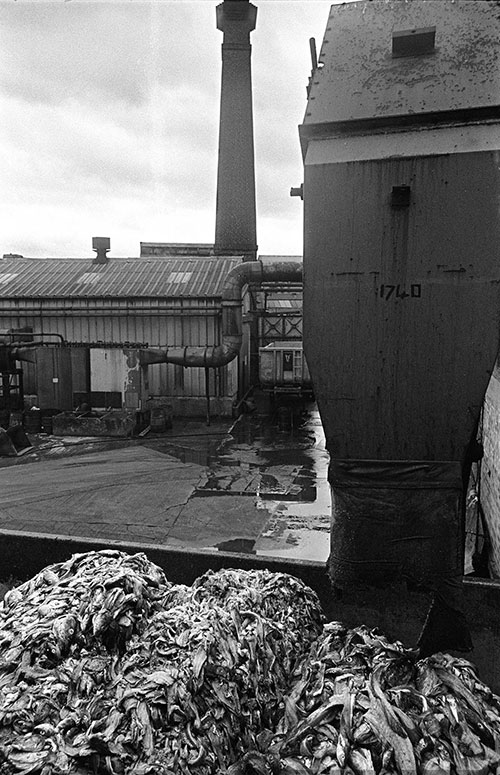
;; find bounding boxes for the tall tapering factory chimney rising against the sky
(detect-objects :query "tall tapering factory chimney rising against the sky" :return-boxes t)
[214,0,257,261]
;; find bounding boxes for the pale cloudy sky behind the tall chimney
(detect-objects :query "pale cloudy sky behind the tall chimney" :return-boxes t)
[0,0,340,257]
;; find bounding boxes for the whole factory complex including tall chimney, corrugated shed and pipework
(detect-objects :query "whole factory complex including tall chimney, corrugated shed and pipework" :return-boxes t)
[0,0,302,415]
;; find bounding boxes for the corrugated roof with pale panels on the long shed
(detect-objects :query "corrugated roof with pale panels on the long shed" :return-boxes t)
[0,256,242,299]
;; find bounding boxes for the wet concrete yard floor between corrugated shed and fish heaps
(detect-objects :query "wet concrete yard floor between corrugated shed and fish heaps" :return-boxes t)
[0,404,330,563]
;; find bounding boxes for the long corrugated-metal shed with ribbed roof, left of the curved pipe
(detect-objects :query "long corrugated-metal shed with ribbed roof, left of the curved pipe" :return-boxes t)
[0,251,245,415]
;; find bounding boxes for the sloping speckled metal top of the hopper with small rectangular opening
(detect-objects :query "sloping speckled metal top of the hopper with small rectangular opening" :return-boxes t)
[305,0,500,124]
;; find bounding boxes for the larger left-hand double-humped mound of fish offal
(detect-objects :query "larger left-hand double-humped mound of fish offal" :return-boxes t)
[0,551,322,775]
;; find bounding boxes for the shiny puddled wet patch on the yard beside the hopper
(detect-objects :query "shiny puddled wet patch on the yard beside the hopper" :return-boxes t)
[170,404,331,562]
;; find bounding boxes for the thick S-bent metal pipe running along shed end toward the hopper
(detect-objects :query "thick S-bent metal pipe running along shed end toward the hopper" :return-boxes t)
[139,261,302,368]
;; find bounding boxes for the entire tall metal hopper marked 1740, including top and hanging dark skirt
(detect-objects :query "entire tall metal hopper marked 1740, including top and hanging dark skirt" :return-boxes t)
[301,0,500,596]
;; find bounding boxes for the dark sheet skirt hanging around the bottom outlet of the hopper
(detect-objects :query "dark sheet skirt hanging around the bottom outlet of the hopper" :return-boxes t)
[328,461,463,590]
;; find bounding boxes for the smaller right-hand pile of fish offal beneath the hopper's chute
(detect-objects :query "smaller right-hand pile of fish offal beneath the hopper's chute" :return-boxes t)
[232,622,500,775]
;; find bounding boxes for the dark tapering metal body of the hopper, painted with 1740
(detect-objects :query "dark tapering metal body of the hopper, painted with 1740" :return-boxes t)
[304,148,500,460]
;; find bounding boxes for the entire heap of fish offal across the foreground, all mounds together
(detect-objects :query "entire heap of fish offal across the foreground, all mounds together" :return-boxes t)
[0,551,500,775]
